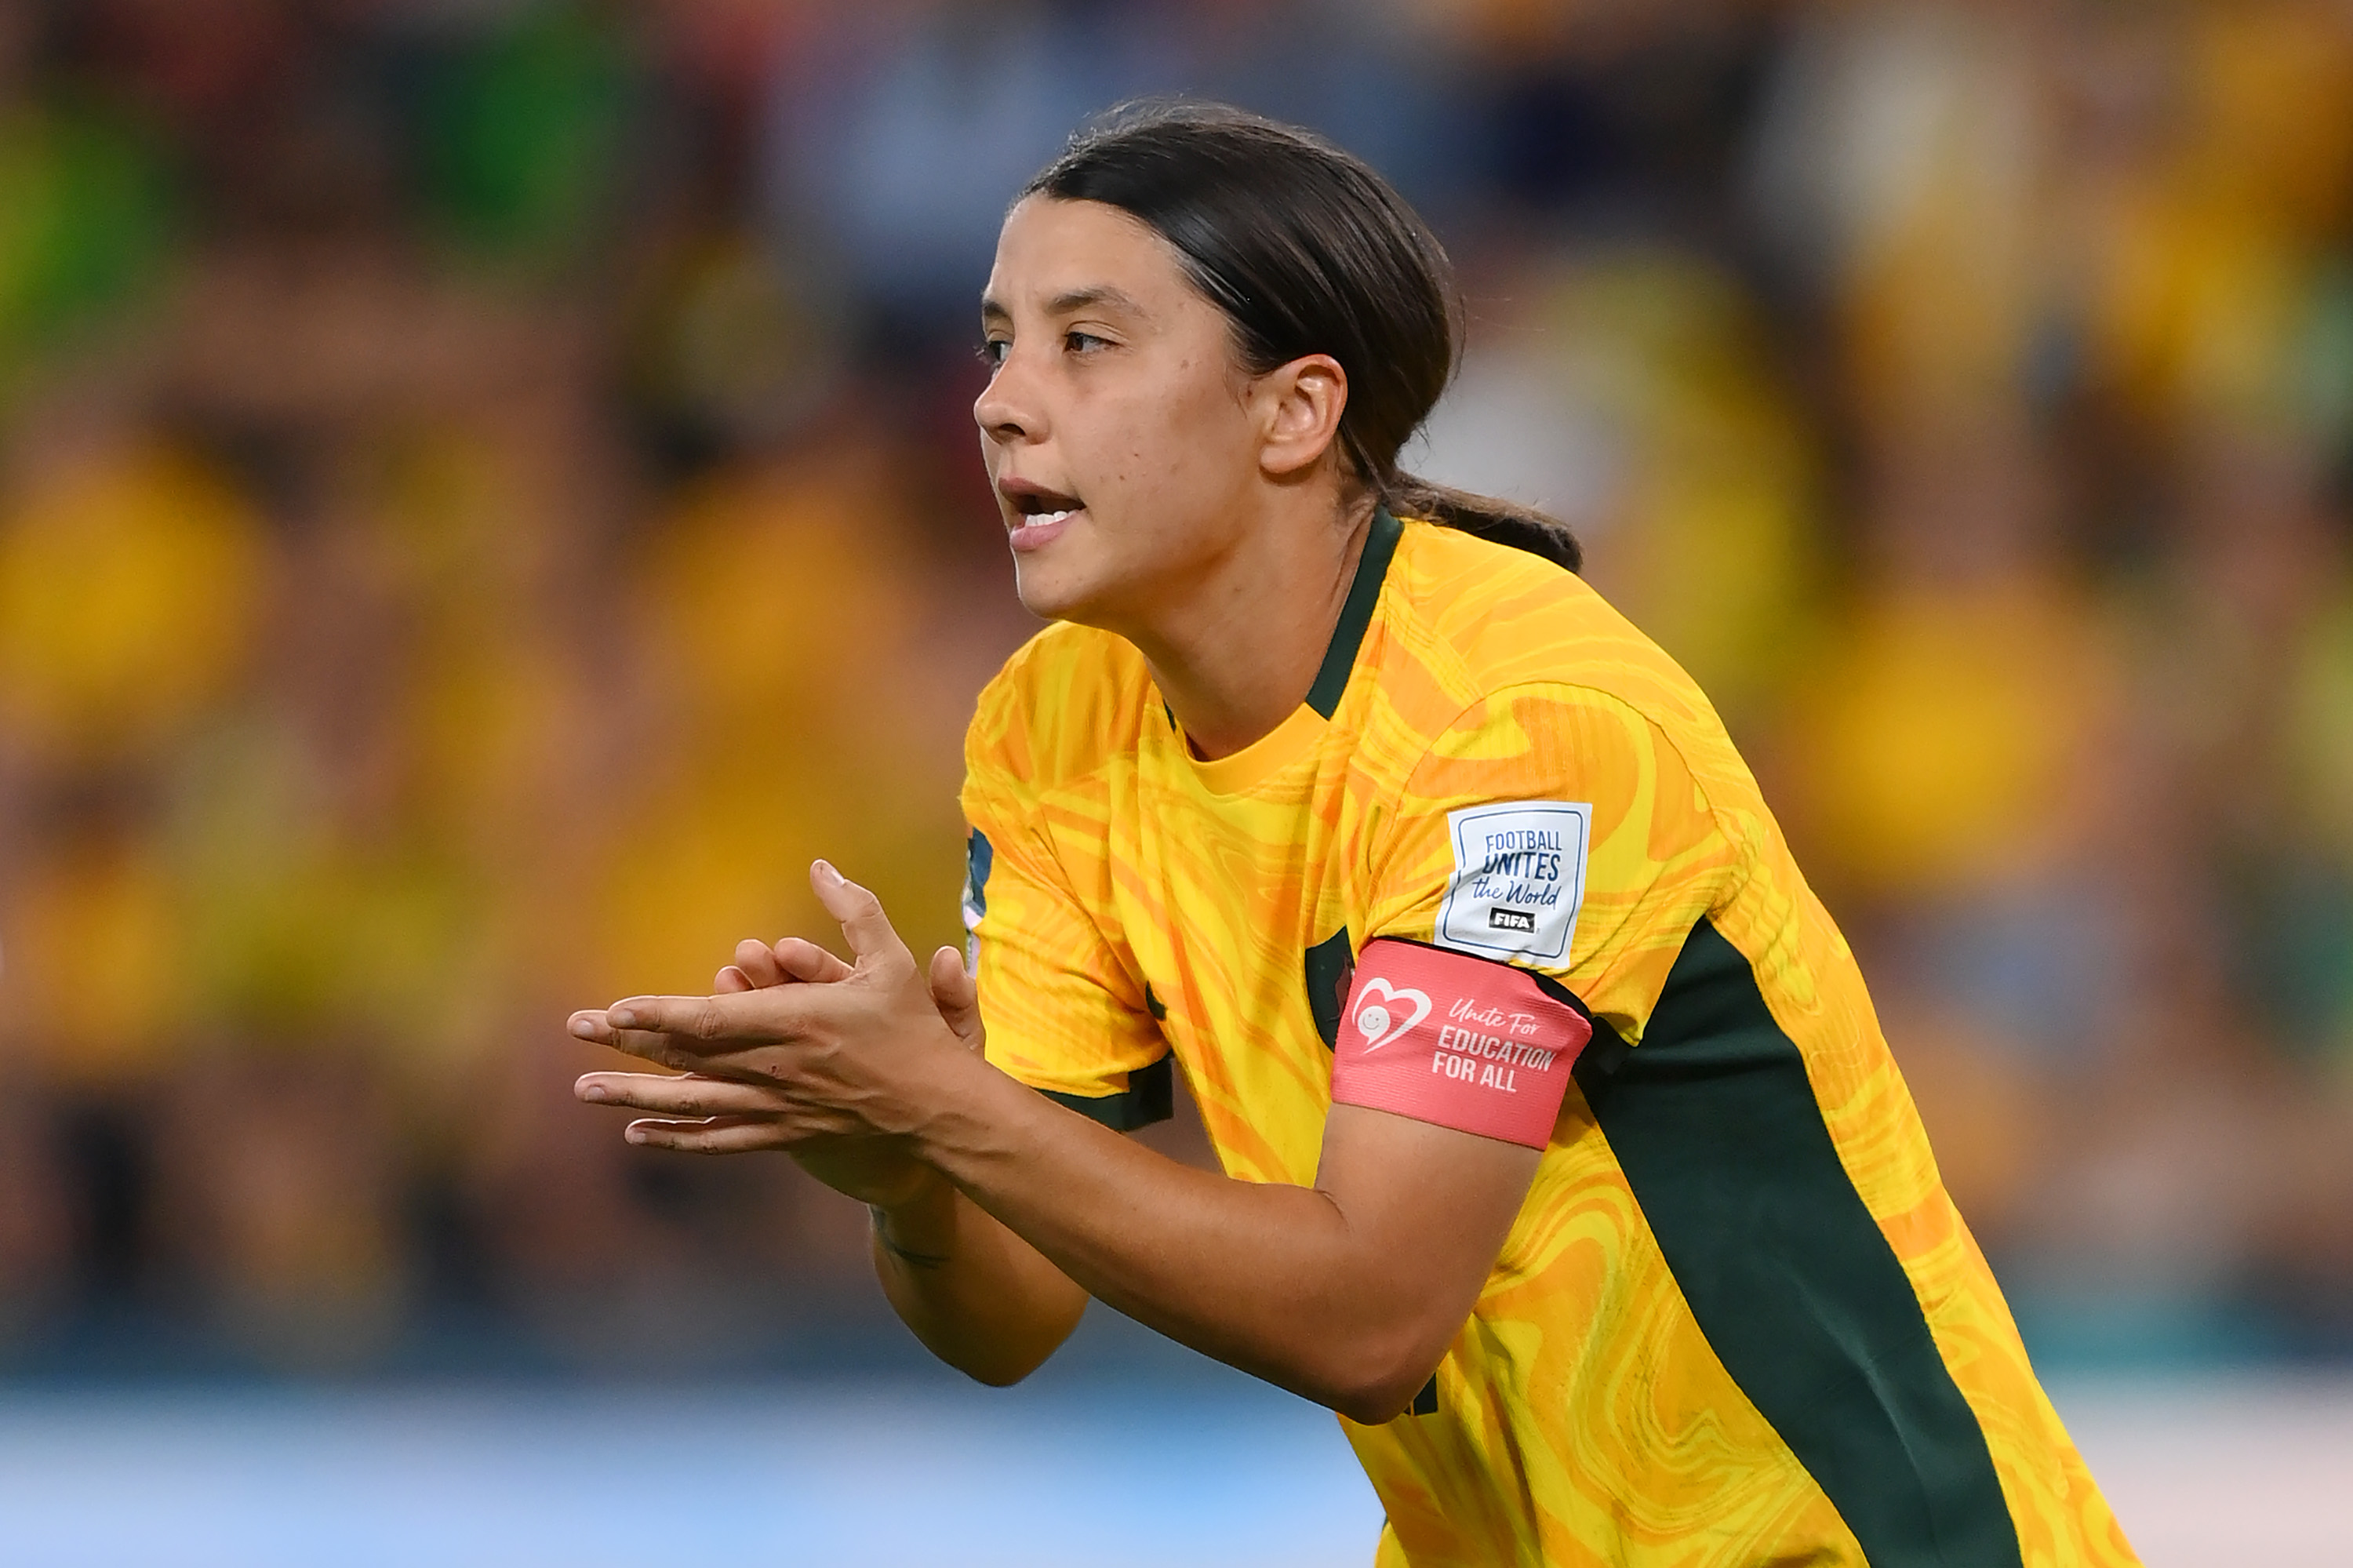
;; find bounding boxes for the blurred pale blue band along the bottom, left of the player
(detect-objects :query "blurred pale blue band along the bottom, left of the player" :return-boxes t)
[0,1314,1381,1568]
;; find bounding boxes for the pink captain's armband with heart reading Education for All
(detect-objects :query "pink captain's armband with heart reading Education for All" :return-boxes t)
[1332,940,1593,1149]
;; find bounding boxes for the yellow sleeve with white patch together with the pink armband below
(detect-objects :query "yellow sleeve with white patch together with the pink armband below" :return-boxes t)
[1332,685,1737,1149]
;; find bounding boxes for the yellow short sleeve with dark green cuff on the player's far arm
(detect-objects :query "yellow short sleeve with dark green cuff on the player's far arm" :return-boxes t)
[962,720,1174,1130]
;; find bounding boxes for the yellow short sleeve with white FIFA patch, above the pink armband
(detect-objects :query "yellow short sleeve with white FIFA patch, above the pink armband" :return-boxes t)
[1365,682,1739,1046]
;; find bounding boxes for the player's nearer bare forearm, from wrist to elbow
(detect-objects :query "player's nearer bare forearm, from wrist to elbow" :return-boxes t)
[925,1050,1440,1422]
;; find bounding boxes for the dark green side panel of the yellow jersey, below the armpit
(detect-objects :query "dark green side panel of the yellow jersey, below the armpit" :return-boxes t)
[1577,921,2021,1568]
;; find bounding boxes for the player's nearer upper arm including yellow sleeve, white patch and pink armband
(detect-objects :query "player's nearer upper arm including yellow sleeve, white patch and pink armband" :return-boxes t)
[1318,685,1732,1393]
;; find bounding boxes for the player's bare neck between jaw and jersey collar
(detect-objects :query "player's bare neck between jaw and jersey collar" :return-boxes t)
[1127,489,1374,760]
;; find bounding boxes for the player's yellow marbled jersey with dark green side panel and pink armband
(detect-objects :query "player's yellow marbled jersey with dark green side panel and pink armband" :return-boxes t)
[962,511,2134,1568]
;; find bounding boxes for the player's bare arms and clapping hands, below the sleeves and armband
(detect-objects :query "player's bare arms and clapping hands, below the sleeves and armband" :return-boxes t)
[572,876,1539,1422]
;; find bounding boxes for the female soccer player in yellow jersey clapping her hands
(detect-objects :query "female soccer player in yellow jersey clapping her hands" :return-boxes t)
[572,106,2132,1568]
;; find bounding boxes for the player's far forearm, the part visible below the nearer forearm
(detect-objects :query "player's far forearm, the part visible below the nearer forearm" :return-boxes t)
[871,1180,1087,1387]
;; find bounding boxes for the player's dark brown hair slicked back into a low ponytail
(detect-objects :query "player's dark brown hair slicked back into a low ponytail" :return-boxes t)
[1021,101,1581,572]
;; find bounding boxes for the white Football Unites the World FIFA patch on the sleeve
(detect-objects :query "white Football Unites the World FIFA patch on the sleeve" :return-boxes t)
[1435,801,1593,966]
